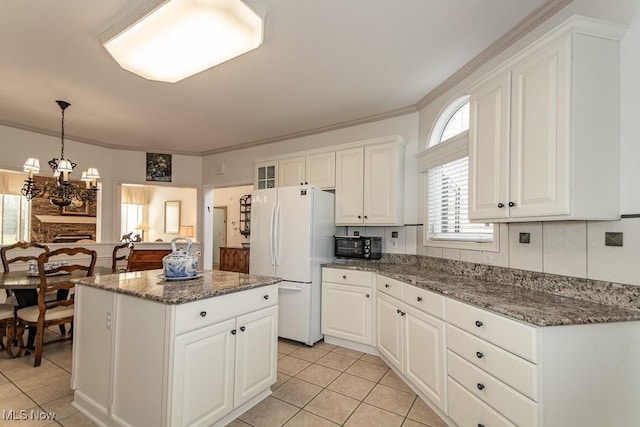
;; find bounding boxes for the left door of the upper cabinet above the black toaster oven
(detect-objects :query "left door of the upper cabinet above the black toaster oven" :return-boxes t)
[335,148,364,225]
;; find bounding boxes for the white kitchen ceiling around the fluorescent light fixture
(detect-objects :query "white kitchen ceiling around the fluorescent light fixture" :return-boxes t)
[0,0,544,154]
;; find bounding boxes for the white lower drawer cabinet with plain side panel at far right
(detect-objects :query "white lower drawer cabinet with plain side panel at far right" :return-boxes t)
[446,298,640,427]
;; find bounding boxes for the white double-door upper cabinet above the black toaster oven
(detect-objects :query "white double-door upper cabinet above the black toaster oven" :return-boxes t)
[335,138,405,226]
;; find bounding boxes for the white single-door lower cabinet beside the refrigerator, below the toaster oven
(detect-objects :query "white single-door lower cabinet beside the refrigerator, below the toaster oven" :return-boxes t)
[322,268,374,345]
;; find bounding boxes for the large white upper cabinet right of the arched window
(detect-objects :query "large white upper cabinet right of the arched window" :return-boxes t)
[469,18,622,222]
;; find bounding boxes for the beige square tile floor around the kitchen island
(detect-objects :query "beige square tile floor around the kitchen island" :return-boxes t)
[0,330,446,427]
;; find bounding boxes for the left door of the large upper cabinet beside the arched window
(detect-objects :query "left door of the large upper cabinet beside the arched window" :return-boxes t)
[469,73,511,219]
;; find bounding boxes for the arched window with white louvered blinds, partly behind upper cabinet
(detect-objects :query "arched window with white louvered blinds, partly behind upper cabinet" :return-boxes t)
[420,96,496,249]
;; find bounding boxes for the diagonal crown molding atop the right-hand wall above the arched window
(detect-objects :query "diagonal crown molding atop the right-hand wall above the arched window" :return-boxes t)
[416,0,573,110]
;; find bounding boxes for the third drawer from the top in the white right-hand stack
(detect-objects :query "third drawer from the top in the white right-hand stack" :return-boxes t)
[447,351,538,427]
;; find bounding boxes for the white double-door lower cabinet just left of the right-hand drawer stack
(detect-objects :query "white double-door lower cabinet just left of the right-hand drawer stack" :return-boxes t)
[376,275,446,412]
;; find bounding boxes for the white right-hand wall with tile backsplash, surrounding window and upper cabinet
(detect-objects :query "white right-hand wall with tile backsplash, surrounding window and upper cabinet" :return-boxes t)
[417,0,640,285]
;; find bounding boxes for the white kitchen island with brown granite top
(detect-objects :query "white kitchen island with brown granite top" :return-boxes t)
[72,270,280,426]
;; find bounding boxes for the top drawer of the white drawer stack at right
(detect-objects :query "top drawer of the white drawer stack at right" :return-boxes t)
[447,298,538,363]
